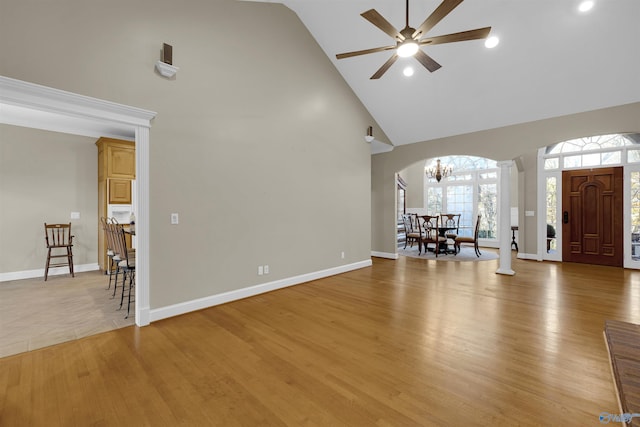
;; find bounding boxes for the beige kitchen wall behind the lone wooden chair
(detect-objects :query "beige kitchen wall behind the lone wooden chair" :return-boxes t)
[0,124,98,273]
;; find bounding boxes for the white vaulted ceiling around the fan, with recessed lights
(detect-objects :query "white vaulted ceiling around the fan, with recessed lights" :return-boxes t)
[259,0,640,145]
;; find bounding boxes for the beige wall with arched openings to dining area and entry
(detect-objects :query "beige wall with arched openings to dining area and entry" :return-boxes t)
[371,103,640,253]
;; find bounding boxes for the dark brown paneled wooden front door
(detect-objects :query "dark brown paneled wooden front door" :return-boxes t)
[562,167,624,267]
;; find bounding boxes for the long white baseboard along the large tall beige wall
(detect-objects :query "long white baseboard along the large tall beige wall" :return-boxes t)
[145,259,372,322]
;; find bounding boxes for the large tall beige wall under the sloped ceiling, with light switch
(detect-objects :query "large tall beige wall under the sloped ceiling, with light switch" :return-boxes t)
[0,0,374,309]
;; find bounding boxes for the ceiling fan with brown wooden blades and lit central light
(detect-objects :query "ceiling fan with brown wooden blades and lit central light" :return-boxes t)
[336,0,491,80]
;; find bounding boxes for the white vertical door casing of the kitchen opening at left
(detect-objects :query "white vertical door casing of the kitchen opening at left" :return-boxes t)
[134,126,150,326]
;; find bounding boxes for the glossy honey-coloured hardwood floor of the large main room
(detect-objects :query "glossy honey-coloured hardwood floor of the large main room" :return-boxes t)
[0,257,640,426]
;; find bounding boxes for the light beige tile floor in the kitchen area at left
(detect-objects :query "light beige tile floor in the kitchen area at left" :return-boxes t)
[0,271,135,357]
